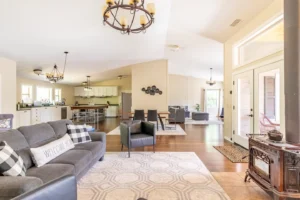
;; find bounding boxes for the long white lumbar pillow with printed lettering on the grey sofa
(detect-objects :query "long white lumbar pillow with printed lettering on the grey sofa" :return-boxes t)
[30,134,75,167]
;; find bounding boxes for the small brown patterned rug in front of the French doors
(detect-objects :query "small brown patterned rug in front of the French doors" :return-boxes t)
[214,144,249,163]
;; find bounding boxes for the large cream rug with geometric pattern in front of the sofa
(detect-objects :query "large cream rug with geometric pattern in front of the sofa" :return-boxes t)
[78,152,230,200]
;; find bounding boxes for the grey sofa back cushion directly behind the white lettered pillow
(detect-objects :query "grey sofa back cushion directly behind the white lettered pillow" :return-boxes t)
[18,123,56,148]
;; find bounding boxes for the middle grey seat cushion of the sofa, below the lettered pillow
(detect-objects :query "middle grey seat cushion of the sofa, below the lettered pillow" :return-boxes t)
[26,164,75,184]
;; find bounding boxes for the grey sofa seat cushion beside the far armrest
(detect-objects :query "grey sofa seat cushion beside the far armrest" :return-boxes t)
[49,150,93,175]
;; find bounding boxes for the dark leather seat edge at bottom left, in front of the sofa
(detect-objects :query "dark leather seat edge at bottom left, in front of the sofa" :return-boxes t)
[13,176,77,200]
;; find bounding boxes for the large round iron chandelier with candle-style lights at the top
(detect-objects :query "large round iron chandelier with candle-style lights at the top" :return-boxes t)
[103,0,155,35]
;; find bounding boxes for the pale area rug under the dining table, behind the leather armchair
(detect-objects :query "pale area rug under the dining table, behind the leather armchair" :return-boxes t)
[107,124,186,135]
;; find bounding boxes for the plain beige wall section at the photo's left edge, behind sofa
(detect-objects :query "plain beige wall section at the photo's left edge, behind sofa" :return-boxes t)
[0,58,17,127]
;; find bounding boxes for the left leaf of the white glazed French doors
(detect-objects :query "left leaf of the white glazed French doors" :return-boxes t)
[233,70,254,149]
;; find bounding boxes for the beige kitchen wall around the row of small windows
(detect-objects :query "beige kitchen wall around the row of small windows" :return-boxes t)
[15,77,75,105]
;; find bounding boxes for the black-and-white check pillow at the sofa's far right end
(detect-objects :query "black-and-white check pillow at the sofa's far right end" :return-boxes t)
[67,124,92,145]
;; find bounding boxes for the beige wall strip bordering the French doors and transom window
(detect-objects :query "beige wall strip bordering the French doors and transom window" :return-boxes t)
[224,0,283,138]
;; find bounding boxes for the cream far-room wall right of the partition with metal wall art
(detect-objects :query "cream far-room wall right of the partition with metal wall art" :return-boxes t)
[169,74,223,110]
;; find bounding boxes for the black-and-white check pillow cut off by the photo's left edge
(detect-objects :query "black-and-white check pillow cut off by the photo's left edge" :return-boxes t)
[0,141,26,176]
